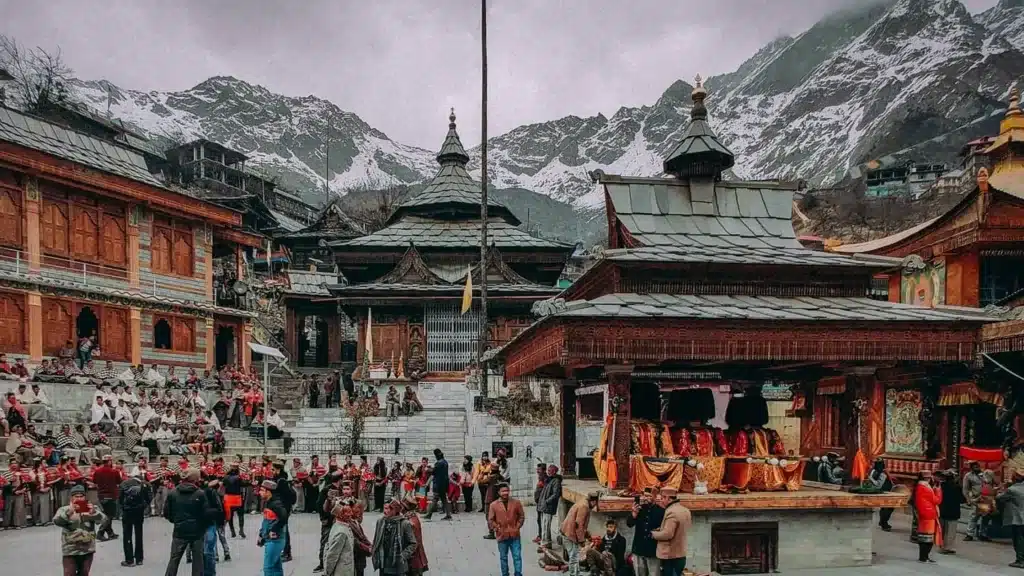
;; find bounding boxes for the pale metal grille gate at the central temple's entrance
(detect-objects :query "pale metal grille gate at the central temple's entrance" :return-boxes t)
[424,303,480,372]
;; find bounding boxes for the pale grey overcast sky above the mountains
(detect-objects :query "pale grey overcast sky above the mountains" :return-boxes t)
[0,0,996,150]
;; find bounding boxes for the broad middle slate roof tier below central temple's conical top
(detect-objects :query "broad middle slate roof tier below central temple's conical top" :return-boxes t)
[329,215,572,250]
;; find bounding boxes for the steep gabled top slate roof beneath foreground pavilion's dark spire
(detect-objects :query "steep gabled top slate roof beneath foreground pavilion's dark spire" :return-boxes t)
[601,176,811,248]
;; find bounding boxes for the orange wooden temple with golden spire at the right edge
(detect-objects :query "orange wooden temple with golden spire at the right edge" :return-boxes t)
[830,88,1024,471]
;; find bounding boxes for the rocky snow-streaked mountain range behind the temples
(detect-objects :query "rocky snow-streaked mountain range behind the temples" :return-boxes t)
[76,0,1024,208]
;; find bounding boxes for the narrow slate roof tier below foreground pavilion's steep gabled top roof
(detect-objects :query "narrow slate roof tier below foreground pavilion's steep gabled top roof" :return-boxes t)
[603,246,902,270]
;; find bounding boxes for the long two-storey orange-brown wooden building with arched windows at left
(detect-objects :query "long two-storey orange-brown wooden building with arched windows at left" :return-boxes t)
[0,107,264,368]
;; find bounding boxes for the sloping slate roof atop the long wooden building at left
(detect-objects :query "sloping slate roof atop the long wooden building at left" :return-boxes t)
[0,107,164,188]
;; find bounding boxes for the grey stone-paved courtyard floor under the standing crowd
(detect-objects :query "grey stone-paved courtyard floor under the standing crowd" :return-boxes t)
[0,508,1024,576]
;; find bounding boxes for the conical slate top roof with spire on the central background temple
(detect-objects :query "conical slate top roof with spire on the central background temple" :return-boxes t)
[387,109,519,225]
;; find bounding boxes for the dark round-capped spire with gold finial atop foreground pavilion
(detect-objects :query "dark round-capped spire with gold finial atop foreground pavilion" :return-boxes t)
[665,75,735,180]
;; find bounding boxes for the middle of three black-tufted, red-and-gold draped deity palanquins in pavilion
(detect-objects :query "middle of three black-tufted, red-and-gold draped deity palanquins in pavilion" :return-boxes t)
[666,388,729,458]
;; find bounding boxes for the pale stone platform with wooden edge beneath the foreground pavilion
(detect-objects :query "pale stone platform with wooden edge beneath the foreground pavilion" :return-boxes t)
[559,480,907,572]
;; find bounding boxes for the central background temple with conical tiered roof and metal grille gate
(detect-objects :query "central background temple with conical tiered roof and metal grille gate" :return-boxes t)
[286,112,573,379]
